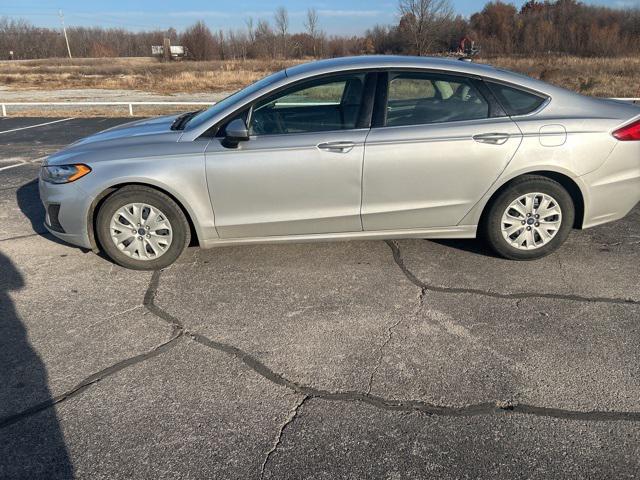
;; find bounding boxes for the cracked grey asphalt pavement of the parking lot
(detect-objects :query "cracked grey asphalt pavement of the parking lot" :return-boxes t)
[0,118,640,479]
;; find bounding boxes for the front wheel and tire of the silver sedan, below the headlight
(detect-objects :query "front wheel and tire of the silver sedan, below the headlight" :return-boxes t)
[96,186,191,270]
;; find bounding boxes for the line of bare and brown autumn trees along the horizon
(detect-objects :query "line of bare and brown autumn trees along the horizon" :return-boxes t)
[0,0,640,60]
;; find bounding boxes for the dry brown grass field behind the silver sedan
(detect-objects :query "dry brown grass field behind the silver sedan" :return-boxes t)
[0,56,640,97]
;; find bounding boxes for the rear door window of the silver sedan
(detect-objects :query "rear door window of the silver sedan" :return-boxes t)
[386,73,489,127]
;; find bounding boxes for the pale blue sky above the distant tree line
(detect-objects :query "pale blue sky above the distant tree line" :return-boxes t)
[0,0,640,35]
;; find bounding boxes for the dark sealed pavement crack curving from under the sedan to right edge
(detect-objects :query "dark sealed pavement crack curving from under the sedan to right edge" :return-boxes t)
[385,240,640,305]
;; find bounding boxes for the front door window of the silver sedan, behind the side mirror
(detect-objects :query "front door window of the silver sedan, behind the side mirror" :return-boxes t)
[249,74,365,135]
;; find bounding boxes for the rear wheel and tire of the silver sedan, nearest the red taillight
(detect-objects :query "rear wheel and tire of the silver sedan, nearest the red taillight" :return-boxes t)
[479,175,575,260]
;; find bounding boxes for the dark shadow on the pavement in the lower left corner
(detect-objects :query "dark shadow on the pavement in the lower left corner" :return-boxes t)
[0,253,74,479]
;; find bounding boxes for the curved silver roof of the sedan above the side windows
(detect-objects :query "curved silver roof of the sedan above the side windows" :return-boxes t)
[285,55,564,95]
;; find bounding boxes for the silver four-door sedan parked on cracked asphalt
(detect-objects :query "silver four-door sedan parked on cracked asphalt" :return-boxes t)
[40,56,640,270]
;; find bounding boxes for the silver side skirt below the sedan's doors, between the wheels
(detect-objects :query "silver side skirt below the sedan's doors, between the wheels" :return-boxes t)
[201,225,478,248]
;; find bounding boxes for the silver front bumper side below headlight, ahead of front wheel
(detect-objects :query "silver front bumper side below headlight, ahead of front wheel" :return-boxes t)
[38,180,93,249]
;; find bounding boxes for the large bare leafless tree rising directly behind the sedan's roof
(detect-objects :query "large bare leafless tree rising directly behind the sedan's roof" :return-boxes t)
[398,0,453,56]
